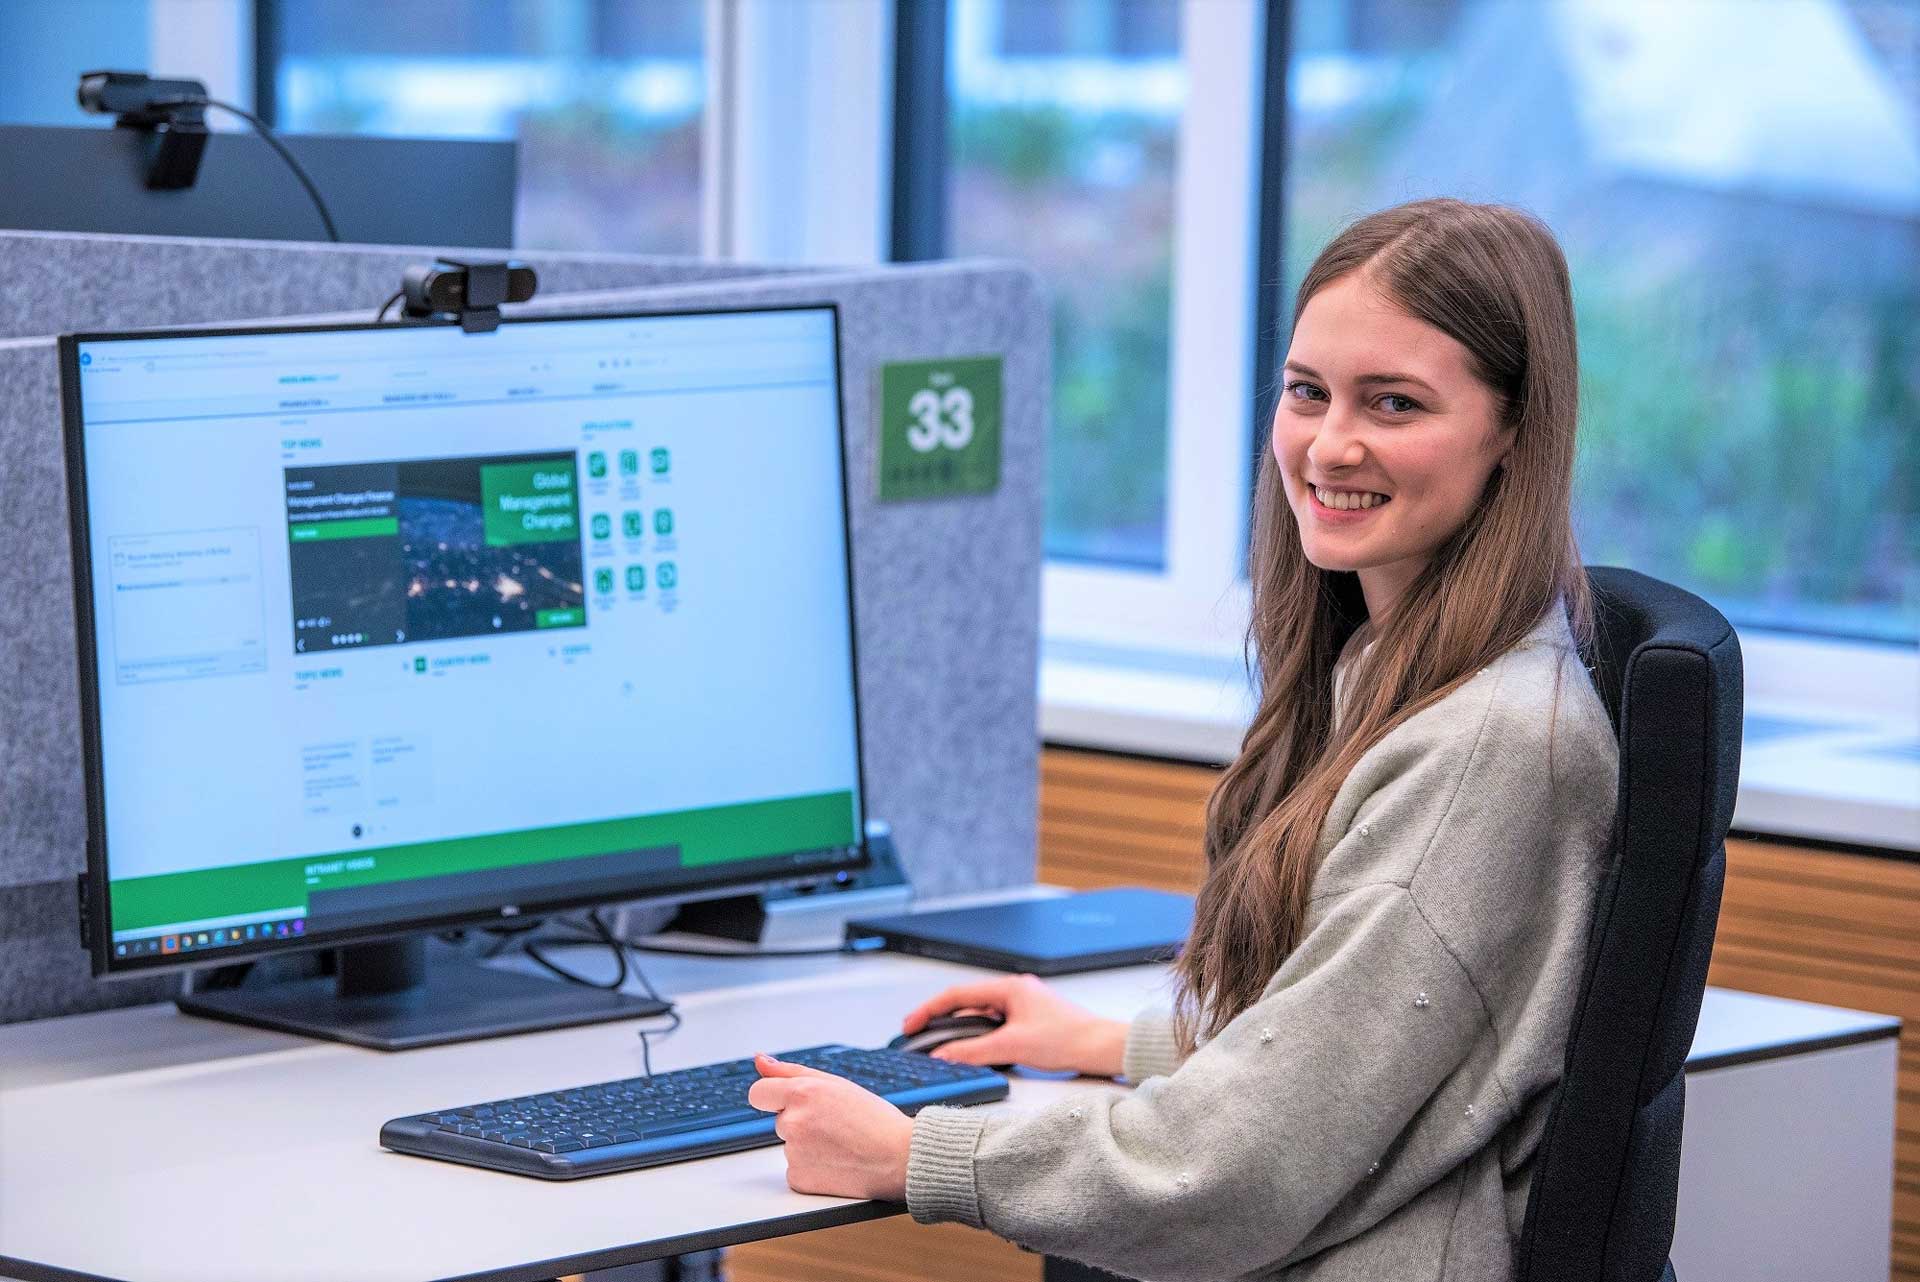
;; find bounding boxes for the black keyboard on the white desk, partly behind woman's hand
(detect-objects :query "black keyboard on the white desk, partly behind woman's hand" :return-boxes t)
[380,1046,1006,1180]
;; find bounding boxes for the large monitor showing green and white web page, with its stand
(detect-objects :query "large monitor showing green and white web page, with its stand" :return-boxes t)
[60,305,866,1044]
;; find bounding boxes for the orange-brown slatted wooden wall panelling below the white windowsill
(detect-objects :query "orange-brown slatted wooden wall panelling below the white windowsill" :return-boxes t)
[730,748,1920,1282]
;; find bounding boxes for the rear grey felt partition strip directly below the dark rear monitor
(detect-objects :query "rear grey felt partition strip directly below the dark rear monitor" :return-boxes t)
[0,232,793,338]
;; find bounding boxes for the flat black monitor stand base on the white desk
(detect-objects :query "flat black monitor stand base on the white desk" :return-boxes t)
[177,937,672,1050]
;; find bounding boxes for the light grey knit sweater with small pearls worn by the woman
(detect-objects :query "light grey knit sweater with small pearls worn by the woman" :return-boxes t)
[906,610,1619,1282]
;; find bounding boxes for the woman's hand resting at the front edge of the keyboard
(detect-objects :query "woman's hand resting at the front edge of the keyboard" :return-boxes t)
[747,1056,914,1201]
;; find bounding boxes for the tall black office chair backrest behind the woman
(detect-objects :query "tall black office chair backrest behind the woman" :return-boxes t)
[1519,568,1741,1282]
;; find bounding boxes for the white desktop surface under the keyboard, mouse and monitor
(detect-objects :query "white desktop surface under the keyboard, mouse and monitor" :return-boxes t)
[0,936,1897,1282]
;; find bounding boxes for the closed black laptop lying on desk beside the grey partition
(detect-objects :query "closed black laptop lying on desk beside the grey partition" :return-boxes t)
[847,887,1194,975]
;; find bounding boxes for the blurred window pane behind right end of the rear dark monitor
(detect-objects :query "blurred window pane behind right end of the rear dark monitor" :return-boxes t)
[261,0,707,253]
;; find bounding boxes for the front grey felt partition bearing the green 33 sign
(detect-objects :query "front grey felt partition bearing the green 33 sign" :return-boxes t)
[0,257,1050,1021]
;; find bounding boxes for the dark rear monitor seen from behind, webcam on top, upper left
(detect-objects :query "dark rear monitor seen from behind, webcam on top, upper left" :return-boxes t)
[0,125,518,249]
